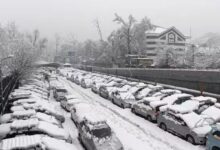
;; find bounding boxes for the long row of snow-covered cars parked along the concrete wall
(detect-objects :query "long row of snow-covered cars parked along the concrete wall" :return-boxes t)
[58,69,220,150]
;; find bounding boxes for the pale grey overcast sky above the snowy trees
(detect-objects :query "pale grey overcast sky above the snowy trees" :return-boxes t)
[0,0,220,41]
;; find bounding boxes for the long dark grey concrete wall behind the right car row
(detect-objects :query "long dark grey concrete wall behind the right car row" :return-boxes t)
[90,67,220,94]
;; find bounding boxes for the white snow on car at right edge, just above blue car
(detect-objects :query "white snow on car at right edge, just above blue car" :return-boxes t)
[201,106,220,121]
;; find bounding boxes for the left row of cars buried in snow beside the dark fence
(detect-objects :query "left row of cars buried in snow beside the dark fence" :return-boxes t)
[0,70,77,150]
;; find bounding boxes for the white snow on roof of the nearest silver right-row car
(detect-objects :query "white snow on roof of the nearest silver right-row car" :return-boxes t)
[168,100,199,114]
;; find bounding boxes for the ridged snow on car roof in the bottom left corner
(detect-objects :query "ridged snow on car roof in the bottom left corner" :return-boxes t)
[0,135,41,150]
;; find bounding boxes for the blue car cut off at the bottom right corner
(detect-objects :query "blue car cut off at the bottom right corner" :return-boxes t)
[206,123,220,150]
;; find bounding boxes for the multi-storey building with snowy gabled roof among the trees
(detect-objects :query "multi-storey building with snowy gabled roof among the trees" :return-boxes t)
[145,26,188,59]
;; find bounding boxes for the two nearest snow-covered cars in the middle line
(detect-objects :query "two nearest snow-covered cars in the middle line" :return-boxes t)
[57,90,123,150]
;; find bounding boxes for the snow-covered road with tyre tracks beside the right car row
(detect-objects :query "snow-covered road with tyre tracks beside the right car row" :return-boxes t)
[59,77,205,150]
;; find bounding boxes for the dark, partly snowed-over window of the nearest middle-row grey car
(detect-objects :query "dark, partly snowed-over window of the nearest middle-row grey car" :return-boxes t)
[92,125,111,138]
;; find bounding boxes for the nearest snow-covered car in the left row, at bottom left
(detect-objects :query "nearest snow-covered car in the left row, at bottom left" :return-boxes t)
[0,134,77,150]
